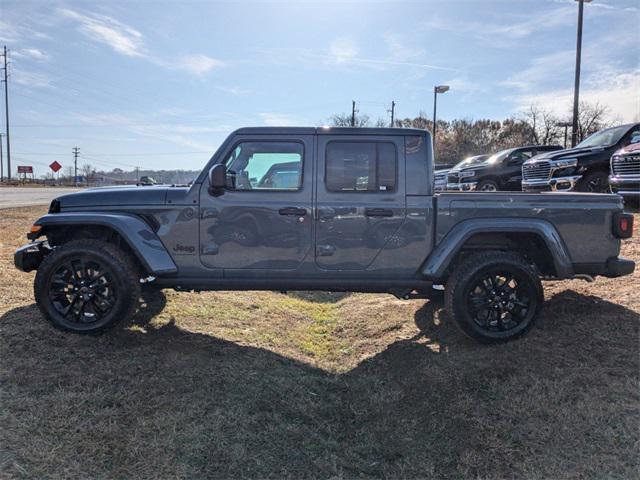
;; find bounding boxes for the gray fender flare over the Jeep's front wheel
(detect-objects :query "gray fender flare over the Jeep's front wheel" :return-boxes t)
[35,212,178,276]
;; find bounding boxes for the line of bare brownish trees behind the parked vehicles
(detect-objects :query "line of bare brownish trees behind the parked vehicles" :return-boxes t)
[331,102,616,163]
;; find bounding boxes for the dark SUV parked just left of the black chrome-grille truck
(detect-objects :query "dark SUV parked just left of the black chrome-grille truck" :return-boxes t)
[447,145,562,192]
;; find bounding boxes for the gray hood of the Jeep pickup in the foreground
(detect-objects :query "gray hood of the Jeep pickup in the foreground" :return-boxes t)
[56,185,172,209]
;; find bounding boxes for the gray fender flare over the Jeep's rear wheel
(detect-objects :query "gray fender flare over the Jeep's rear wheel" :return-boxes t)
[421,218,573,280]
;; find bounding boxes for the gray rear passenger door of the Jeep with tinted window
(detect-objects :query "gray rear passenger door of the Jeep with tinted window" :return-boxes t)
[315,135,406,270]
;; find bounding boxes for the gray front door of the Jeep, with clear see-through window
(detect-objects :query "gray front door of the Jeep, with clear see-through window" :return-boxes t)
[200,135,313,270]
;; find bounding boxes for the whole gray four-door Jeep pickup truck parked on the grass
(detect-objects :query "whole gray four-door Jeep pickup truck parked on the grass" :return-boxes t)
[15,128,635,342]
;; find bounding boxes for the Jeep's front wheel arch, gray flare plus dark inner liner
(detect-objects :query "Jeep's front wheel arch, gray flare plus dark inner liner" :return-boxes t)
[35,212,178,276]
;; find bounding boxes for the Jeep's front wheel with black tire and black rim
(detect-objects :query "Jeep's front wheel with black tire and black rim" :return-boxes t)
[34,239,140,334]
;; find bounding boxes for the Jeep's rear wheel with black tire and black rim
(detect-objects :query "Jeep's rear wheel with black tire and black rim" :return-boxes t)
[445,251,544,343]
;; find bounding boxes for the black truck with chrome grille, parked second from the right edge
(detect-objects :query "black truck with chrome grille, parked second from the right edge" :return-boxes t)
[522,123,640,193]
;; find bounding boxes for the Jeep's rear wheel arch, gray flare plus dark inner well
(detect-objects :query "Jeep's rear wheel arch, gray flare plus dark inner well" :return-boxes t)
[421,218,573,281]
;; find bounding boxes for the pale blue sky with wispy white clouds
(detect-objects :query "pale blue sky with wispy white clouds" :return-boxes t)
[0,0,640,176]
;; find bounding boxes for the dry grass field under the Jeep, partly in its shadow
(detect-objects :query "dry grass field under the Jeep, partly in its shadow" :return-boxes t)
[0,207,640,479]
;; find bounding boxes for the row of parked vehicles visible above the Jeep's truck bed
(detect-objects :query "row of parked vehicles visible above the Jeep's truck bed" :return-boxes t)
[435,123,640,197]
